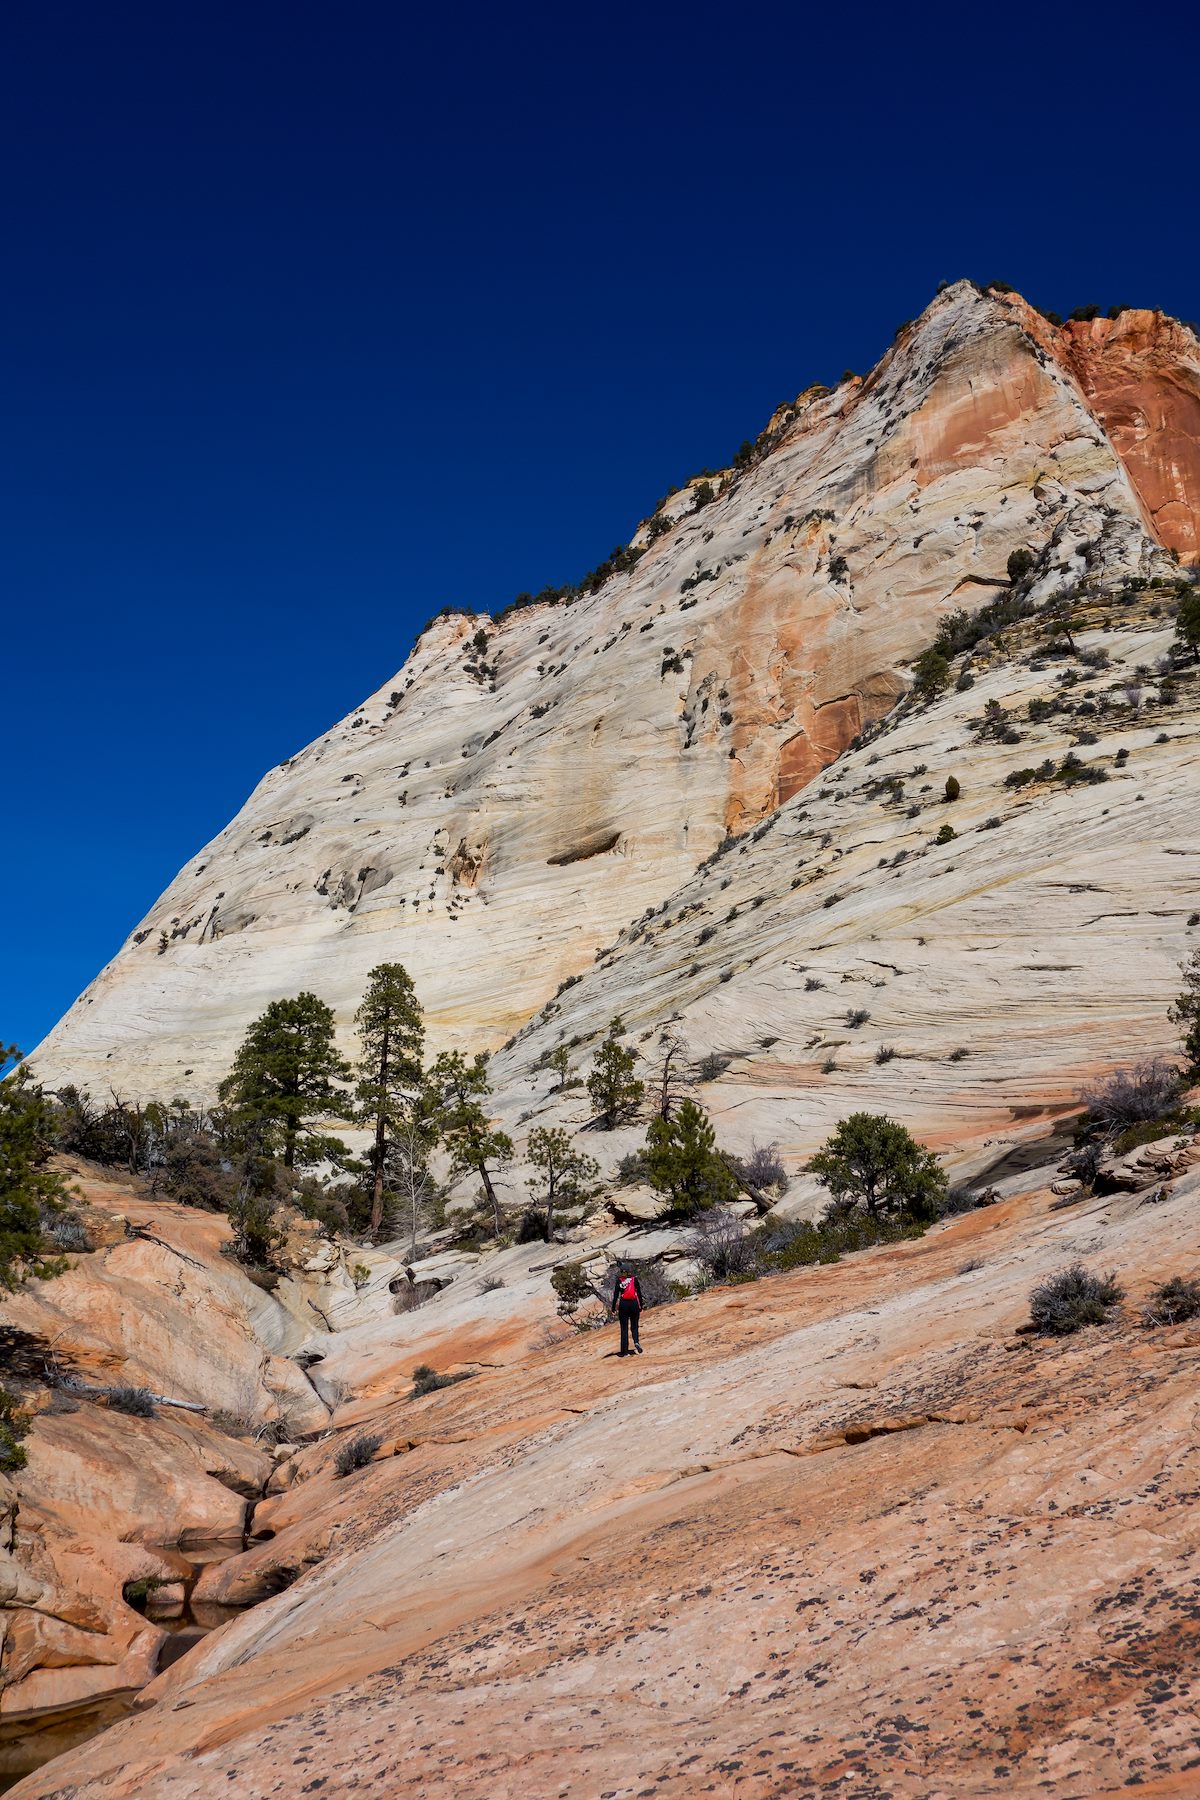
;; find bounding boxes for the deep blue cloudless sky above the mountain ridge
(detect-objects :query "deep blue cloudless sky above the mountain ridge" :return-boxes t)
[0,0,1200,1049]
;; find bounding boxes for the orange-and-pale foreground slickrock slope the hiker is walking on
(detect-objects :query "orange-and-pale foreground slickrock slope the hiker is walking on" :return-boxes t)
[14,1143,1200,1800]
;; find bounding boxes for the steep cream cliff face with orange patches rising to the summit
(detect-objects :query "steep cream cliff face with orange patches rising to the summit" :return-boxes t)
[34,283,1200,1098]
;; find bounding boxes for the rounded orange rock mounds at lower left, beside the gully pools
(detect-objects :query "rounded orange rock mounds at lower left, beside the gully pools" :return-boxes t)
[0,1179,327,1780]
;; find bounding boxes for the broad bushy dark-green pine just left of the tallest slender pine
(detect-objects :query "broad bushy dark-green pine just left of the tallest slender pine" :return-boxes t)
[219,994,351,1168]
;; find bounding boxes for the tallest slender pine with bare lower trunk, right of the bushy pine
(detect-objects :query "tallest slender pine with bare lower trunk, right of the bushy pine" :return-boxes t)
[354,963,425,1238]
